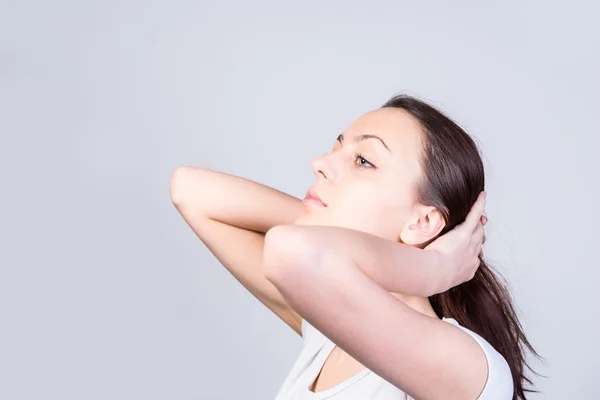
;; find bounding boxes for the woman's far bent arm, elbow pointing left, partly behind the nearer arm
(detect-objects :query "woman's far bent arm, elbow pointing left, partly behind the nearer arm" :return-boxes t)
[169,166,302,335]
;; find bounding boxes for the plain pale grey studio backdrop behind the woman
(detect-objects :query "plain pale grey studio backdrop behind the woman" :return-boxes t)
[0,0,600,400]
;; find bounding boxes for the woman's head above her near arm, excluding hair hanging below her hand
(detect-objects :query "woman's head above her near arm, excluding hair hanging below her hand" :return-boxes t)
[297,95,484,247]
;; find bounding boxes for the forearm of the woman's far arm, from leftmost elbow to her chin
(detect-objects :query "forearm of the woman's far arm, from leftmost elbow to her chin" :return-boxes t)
[170,166,302,233]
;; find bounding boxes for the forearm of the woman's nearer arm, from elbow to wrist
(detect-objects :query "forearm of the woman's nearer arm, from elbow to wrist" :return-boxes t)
[265,225,445,297]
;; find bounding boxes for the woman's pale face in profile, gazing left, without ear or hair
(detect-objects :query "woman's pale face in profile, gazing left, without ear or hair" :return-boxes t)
[295,108,424,241]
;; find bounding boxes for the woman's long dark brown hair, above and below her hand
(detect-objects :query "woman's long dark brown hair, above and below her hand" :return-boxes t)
[382,94,541,400]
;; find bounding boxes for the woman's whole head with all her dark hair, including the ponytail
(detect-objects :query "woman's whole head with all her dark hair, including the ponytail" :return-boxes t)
[296,95,539,399]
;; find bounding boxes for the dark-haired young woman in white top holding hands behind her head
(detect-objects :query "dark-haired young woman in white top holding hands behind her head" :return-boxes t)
[170,95,536,400]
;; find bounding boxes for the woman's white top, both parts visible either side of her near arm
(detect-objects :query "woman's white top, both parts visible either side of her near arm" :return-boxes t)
[275,318,513,400]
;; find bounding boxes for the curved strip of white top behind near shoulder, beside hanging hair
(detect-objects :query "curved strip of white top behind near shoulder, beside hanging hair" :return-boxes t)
[442,318,514,400]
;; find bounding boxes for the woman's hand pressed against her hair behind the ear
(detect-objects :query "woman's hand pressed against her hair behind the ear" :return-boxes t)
[425,192,487,293]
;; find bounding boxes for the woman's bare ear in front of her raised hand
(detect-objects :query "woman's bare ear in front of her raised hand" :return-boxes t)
[399,207,446,246]
